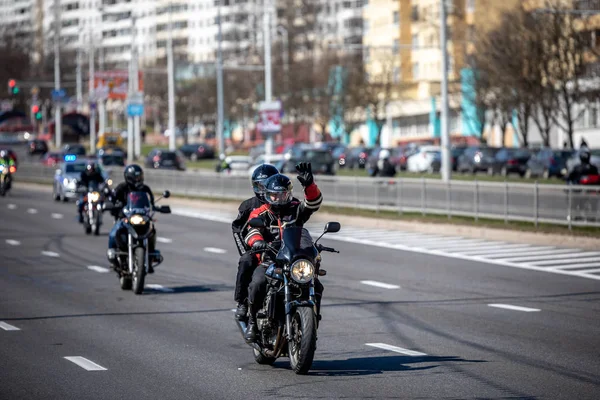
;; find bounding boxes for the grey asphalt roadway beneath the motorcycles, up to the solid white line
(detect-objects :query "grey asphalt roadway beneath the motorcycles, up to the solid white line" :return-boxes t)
[0,185,600,399]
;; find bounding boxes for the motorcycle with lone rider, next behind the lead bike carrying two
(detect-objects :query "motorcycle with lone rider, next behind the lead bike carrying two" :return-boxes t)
[105,190,171,294]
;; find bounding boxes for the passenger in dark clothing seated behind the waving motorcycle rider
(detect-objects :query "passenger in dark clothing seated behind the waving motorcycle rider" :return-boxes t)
[231,164,279,319]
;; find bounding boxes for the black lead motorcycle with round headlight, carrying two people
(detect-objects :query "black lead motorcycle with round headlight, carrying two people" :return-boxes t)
[236,218,341,374]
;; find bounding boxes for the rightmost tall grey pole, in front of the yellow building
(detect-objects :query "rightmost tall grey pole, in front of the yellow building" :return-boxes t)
[440,0,452,182]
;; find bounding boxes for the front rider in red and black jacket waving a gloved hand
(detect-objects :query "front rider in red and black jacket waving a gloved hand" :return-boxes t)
[244,163,323,342]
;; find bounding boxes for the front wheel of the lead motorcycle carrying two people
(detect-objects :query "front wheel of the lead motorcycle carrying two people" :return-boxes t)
[288,307,317,375]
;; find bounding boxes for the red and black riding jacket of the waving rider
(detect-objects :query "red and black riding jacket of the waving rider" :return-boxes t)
[244,183,323,247]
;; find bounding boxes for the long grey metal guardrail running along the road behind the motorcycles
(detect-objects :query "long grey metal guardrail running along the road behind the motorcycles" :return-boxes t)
[15,163,600,227]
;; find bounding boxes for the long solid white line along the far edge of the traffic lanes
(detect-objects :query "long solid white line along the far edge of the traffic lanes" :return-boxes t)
[172,209,600,281]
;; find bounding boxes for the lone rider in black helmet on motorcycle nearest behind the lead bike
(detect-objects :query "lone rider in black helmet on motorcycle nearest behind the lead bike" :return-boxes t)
[107,164,161,274]
